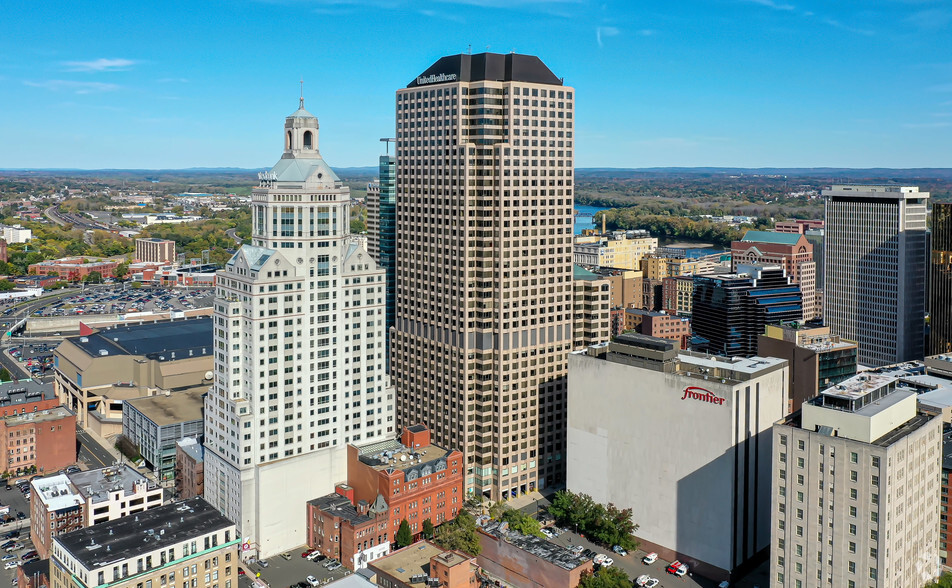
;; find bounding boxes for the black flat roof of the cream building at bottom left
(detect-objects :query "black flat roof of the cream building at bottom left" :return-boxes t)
[54,497,237,570]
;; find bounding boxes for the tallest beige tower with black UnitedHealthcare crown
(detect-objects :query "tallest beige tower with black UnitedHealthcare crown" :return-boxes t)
[391,53,575,499]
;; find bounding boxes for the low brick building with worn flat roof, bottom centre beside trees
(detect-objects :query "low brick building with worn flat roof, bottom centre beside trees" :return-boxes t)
[476,521,594,588]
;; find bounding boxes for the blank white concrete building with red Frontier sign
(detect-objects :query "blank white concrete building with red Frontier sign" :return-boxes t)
[567,354,787,570]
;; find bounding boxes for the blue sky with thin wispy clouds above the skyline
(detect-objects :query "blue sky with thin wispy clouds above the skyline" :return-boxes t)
[0,0,952,169]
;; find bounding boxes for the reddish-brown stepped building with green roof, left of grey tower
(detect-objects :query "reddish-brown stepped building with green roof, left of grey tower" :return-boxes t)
[731,231,820,320]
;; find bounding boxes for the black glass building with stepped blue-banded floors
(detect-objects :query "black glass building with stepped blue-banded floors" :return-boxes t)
[691,265,803,357]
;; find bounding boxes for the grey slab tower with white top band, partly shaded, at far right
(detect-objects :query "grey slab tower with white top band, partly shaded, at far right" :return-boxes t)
[823,185,929,366]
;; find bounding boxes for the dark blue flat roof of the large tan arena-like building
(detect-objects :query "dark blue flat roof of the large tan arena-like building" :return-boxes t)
[66,317,214,361]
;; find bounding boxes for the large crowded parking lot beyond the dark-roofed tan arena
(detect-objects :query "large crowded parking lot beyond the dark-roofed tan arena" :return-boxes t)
[27,284,214,317]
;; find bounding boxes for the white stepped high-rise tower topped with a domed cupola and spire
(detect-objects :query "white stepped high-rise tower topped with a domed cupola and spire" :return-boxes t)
[205,98,394,557]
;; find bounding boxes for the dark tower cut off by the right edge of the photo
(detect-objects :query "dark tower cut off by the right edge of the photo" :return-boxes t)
[929,202,952,355]
